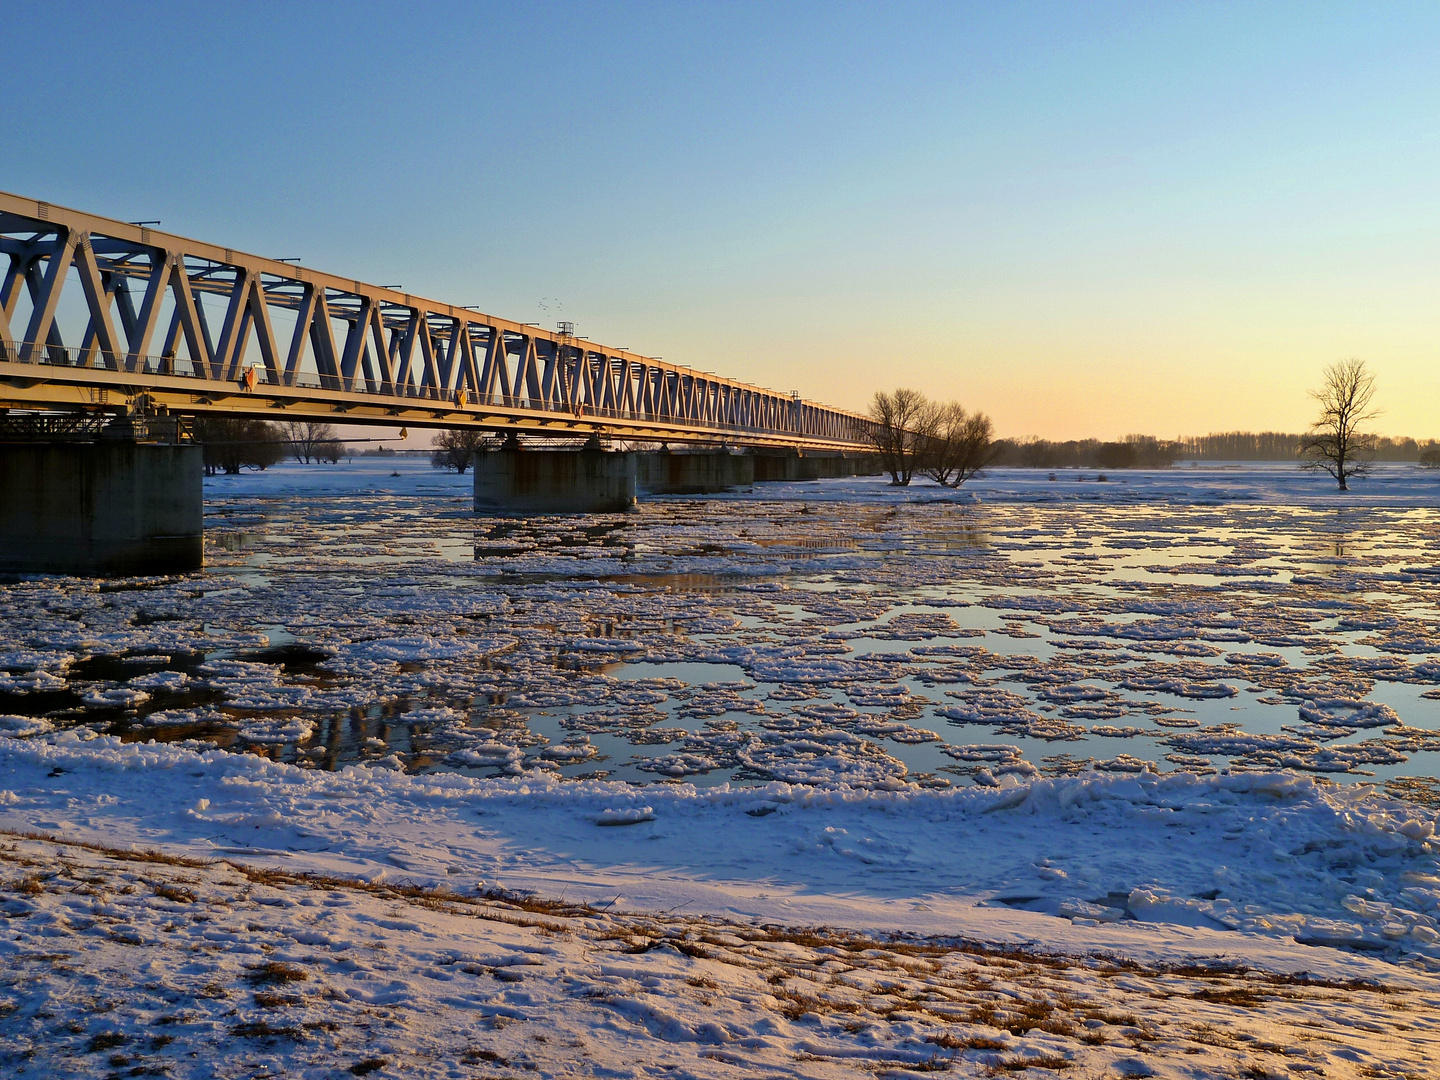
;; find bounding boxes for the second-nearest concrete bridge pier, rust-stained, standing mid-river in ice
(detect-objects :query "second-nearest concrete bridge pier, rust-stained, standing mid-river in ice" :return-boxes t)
[475,446,635,514]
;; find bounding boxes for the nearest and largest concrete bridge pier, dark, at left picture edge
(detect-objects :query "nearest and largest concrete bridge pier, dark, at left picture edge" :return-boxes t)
[0,419,204,577]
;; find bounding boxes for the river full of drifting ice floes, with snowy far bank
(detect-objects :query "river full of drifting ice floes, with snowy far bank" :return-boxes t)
[0,459,1440,799]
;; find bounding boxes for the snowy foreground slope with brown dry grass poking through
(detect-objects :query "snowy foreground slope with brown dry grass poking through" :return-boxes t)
[0,834,1440,1077]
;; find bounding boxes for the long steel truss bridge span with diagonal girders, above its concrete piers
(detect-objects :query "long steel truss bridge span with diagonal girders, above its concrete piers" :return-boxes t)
[0,192,873,452]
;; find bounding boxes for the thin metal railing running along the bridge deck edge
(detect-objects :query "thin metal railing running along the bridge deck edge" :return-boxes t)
[0,338,861,441]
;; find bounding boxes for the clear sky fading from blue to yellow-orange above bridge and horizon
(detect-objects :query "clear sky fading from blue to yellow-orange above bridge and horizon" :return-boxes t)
[11,0,1440,438]
